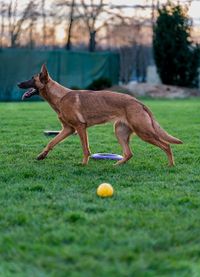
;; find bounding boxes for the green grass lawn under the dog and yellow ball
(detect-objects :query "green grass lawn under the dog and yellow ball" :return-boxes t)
[0,99,200,277]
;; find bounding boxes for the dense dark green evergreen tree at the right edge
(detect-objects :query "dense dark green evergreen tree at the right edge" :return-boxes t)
[153,2,200,87]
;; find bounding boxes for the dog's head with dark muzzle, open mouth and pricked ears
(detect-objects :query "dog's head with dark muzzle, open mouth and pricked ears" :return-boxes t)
[18,64,50,100]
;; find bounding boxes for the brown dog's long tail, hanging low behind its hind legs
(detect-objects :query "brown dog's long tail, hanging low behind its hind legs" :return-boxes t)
[142,104,183,144]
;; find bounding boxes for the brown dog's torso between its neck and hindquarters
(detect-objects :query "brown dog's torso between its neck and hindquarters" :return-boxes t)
[61,90,140,127]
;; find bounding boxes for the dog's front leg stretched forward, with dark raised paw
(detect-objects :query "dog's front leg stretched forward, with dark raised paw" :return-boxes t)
[37,126,75,160]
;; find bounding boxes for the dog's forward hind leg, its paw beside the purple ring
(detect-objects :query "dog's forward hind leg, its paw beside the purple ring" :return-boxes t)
[115,121,133,165]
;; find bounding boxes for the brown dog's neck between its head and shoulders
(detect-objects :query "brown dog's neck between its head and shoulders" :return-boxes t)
[40,79,68,113]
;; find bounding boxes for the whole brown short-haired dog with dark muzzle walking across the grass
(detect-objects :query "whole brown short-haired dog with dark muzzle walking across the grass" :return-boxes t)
[18,65,182,166]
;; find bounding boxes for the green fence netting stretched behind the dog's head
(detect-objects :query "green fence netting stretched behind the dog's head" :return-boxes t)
[0,49,119,101]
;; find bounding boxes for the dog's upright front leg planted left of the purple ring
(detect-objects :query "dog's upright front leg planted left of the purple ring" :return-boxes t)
[76,124,91,165]
